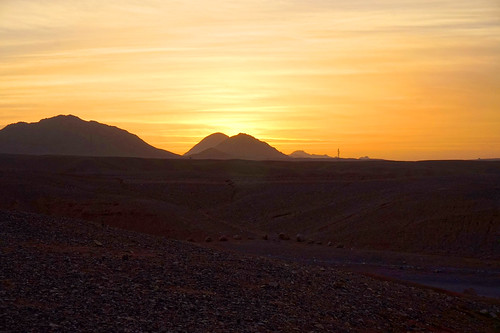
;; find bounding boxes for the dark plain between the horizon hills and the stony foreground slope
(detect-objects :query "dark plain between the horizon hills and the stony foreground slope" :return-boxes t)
[0,155,500,258]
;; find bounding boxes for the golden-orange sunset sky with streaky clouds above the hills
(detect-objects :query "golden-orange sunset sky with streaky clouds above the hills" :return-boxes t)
[0,0,500,160]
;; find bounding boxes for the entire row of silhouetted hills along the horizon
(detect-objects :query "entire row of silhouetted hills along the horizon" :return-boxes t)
[0,115,368,161]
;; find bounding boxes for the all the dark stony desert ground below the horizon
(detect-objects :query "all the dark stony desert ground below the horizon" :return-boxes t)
[0,155,500,332]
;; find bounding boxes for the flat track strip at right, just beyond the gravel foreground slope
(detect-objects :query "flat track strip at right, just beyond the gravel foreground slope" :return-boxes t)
[212,239,500,299]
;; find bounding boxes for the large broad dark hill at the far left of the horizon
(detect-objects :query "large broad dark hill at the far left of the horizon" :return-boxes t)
[0,115,179,158]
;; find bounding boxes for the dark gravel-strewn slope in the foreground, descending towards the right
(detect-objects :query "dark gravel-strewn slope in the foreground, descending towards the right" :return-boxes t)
[0,211,500,332]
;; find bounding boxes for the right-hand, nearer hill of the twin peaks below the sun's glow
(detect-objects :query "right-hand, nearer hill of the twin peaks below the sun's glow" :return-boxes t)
[189,133,288,160]
